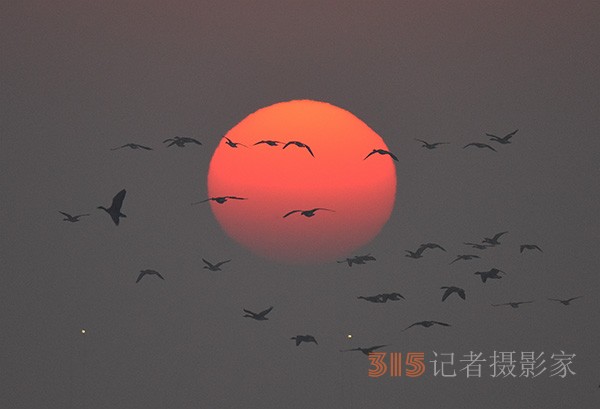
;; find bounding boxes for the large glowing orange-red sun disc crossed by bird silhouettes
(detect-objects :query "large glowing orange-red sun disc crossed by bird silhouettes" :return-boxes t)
[208,100,396,263]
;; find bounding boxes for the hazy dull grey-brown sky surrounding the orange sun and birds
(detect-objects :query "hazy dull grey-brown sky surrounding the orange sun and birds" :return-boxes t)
[0,1,600,409]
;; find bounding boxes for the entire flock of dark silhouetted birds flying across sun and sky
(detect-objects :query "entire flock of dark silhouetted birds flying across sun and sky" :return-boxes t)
[60,129,581,355]
